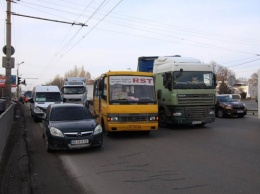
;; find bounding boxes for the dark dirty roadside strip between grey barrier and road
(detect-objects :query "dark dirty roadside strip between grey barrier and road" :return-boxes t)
[0,103,31,194]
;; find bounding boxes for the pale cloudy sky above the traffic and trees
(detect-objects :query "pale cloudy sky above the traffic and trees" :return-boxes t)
[0,0,260,90]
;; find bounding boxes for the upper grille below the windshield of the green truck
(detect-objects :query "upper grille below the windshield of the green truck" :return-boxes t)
[178,94,215,106]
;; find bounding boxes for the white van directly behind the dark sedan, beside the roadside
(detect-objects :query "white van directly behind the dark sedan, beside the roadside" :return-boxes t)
[29,86,62,122]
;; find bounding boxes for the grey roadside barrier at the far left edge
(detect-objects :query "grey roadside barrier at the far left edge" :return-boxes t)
[0,104,15,161]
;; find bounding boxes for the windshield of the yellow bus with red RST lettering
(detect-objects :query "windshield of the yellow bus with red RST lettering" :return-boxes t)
[109,76,156,104]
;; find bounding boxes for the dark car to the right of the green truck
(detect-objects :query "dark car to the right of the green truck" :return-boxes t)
[215,94,247,118]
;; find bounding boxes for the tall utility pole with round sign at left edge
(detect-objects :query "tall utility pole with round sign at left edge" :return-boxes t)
[4,0,12,109]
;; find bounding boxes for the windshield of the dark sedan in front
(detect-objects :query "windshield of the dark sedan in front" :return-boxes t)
[50,107,93,121]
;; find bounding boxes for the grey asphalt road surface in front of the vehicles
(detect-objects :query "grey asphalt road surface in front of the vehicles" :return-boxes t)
[0,102,260,194]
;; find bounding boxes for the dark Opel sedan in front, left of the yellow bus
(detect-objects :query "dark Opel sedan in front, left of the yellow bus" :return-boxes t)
[42,103,103,152]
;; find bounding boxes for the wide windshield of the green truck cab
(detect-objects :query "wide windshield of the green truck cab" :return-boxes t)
[173,71,215,89]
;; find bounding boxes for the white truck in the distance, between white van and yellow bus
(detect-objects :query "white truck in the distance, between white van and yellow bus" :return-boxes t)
[61,77,87,106]
